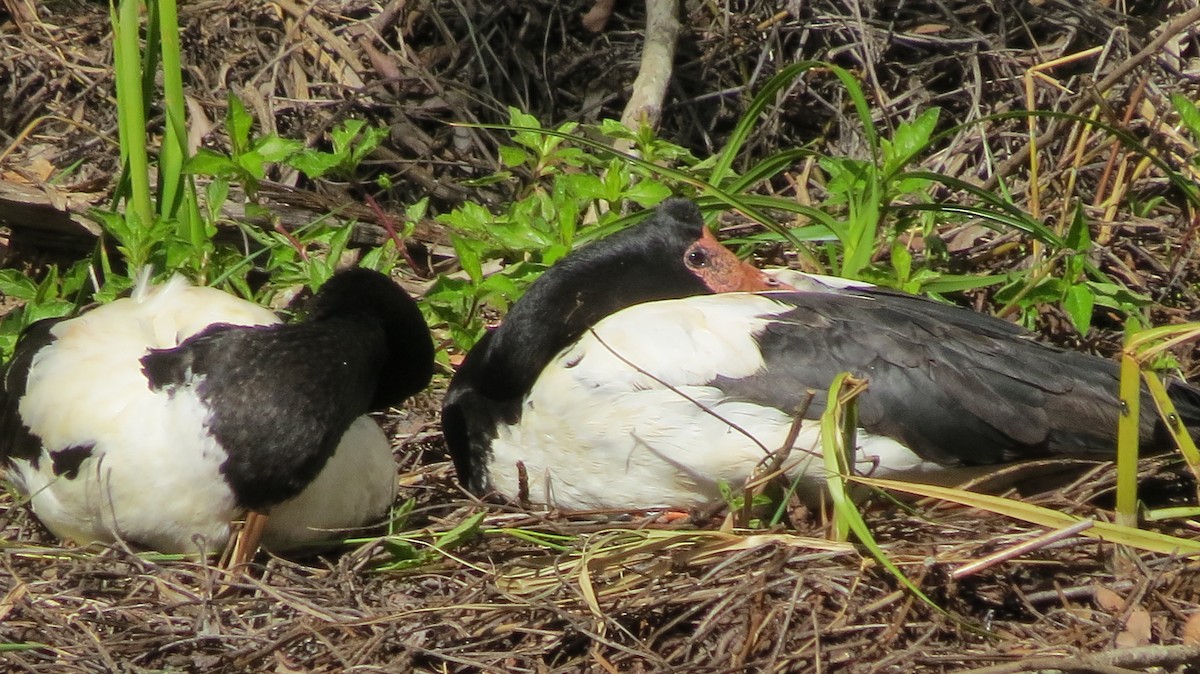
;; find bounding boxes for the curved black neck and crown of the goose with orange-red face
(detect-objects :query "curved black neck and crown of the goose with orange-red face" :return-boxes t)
[463,199,710,401]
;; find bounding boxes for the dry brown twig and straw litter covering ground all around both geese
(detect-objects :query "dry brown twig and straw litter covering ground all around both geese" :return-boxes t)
[0,0,1200,674]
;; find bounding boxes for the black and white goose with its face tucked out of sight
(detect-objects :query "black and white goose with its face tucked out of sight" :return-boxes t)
[0,265,433,553]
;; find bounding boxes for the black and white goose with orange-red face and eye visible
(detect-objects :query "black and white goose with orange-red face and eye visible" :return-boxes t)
[443,199,1200,510]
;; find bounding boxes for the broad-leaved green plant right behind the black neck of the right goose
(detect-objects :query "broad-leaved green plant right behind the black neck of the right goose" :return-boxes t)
[426,109,694,349]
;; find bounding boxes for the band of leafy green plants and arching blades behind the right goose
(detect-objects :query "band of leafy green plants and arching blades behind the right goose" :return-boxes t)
[456,61,1198,345]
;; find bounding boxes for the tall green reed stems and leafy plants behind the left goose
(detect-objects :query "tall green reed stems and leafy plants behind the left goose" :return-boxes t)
[0,0,403,359]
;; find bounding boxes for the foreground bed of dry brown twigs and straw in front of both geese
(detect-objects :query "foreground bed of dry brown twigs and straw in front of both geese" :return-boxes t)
[0,438,1200,673]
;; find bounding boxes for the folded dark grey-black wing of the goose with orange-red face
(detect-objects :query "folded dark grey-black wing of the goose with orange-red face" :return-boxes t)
[718,291,1160,464]
